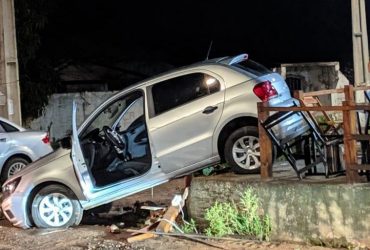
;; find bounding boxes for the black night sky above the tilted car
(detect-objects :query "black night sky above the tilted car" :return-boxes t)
[32,0,370,66]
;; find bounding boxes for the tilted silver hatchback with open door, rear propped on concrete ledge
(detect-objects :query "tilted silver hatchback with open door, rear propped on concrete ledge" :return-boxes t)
[2,54,301,228]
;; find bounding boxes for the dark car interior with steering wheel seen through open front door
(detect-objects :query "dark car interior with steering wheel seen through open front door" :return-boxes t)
[80,95,151,187]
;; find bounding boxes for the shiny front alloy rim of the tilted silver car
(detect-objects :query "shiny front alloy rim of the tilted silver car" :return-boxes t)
[39,193,73,227]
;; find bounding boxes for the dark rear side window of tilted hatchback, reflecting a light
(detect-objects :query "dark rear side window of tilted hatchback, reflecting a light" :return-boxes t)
[152,73,220,115]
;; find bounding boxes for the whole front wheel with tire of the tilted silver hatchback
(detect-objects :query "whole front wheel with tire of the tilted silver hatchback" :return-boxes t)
[31,185,83,228]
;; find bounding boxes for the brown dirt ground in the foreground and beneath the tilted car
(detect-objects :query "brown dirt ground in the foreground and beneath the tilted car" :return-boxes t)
[0,178,342,250]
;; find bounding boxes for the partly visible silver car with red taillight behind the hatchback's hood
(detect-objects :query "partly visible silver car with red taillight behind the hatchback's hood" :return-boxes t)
[0,117,53,183]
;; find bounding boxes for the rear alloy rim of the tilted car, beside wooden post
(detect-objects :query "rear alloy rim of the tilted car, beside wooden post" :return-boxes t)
[232,136,261,170]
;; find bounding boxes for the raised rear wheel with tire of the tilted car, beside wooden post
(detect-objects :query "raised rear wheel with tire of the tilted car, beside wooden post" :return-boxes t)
[224,126,276,174]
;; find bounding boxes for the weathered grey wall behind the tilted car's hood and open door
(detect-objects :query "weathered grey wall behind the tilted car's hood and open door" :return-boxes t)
[26,91,115,143]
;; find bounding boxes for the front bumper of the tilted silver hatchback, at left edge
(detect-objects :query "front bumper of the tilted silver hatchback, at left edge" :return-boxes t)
[1,194,31,228]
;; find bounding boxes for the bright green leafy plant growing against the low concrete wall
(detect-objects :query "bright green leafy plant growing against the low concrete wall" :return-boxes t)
[205,188,271,240]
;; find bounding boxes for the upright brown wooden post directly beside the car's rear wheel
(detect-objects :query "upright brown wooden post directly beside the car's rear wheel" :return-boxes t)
[257,102,272,181]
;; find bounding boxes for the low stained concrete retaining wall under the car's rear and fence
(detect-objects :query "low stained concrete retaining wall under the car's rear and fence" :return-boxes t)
[188,177,370,246]
